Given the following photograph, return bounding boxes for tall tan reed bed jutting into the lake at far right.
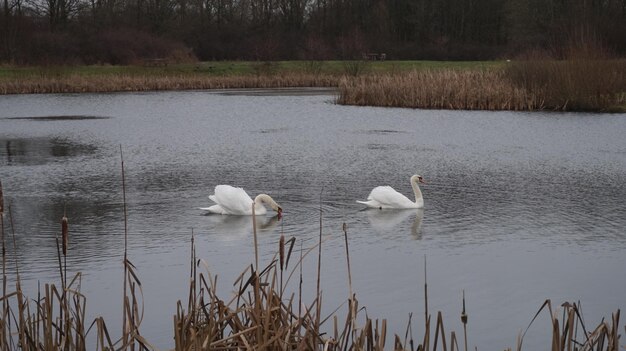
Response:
[338,59,626,112]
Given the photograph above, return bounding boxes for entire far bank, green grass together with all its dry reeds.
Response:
[0,58,626,112]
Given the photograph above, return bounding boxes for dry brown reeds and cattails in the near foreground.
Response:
[0,175,626,351]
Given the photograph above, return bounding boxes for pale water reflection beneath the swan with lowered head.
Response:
[200,214,280,240]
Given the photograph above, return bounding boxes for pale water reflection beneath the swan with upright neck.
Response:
[365,208,424,239]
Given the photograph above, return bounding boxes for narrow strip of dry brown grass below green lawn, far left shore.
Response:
[0,73,338,94]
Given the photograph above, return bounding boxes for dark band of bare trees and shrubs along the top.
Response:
[0,0,626,64]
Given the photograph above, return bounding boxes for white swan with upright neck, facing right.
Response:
[356,174,426,209]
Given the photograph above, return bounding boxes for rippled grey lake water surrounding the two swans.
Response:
[0,90,626,350]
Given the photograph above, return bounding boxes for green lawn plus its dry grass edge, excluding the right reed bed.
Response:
[0,61,500,94]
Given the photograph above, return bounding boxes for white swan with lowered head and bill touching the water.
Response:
[200,185,283,216]
